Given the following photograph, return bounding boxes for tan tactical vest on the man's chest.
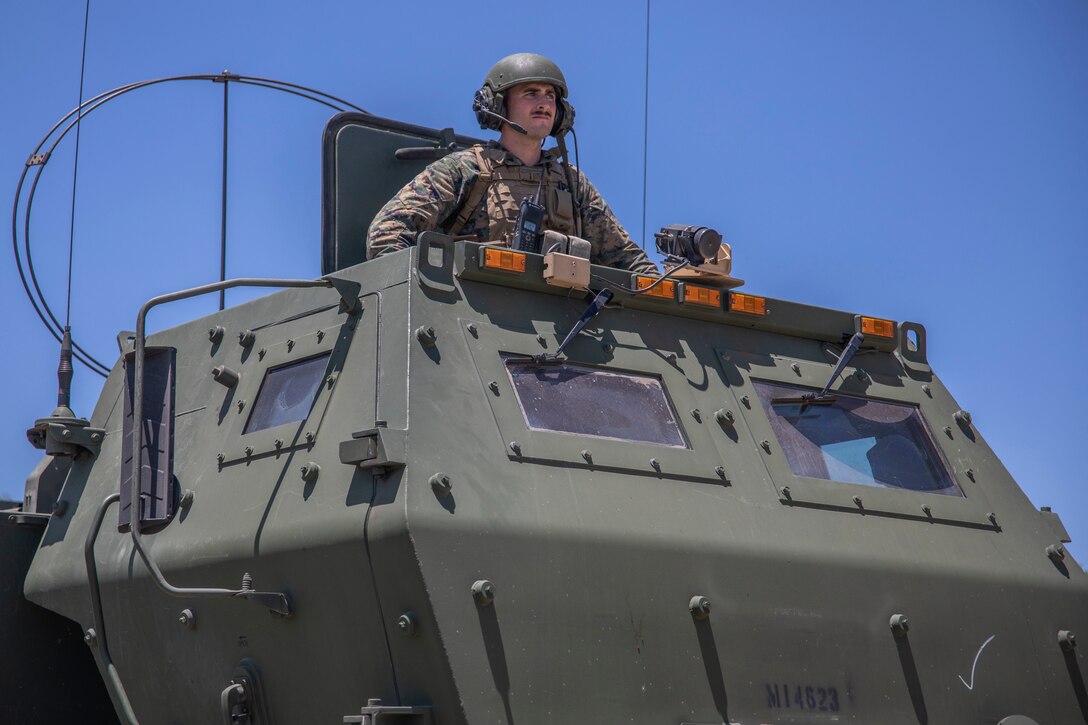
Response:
[449,146,578,245]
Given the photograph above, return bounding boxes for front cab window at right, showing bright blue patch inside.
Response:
[753,381,963,496]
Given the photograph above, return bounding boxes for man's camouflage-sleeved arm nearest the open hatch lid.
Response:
[367,153,478,259]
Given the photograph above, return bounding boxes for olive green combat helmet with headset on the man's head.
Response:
[472,53,574,136]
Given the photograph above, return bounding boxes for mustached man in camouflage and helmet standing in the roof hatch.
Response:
[367,53,657,274]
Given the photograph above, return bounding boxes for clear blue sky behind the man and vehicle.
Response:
[0,0,1088,561]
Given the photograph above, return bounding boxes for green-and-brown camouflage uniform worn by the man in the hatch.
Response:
[367,142,658,274]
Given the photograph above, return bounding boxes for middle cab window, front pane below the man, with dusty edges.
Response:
[507,361,687,447]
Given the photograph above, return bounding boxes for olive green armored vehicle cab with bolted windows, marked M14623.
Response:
[5,115,1088,725]
